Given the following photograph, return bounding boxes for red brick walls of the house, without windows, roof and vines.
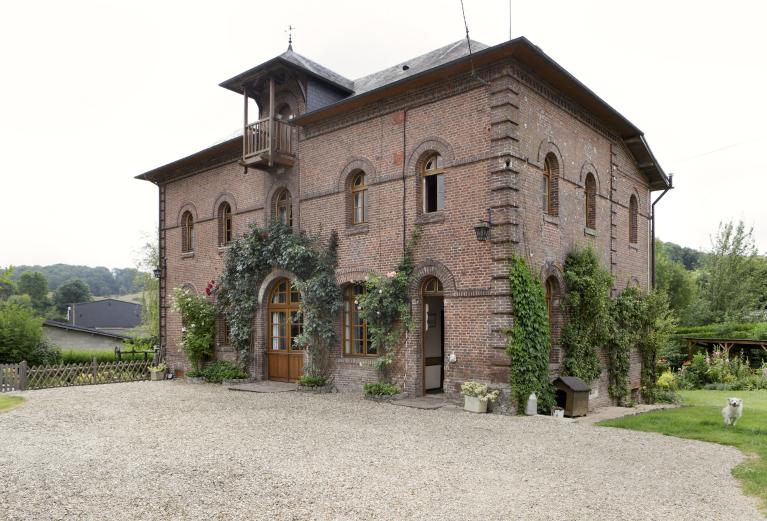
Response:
[160,58,649,402]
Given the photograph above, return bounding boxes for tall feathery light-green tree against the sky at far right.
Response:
[701,221,757,322]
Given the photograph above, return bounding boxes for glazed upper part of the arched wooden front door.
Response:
[269,279,303,352]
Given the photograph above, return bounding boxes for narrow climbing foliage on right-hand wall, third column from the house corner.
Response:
[607,286,645,405]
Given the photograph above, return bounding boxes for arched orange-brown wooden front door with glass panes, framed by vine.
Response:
[267,279,304,382]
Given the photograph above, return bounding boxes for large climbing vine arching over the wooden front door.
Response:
[216,221,341,375]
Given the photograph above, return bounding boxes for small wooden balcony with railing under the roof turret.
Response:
[242,118,295,168]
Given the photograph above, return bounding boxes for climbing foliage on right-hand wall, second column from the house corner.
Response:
[561,247,612,383]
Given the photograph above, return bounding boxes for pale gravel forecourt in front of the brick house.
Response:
[0,382,764,521]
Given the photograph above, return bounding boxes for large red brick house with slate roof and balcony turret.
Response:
[138,38,669,402]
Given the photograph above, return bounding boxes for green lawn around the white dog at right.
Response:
[599,391,767,512]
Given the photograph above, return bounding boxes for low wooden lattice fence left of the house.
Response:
[0,359,151,392]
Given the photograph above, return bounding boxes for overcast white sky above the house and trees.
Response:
[0,0,767,268]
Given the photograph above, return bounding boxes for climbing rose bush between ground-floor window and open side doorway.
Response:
[358,228,419,380]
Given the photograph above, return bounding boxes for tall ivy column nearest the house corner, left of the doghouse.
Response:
[506,256,554,414]
